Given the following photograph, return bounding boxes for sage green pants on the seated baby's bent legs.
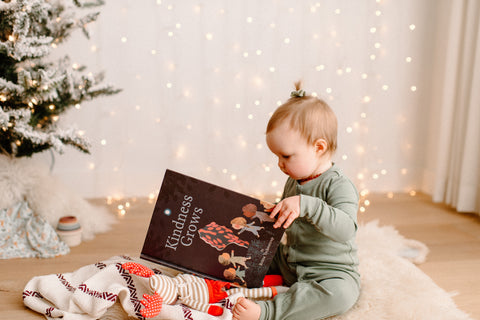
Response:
[257,251,360,320]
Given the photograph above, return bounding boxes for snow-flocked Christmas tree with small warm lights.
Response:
[0,0,119,157]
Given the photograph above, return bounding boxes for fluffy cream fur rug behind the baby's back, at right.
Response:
[94,221,473,320]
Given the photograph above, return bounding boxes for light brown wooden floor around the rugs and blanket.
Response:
[0,194,480,319]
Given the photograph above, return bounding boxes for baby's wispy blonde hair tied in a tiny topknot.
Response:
[266,81,338,154]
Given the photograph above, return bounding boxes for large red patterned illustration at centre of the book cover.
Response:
[198,222,249,251]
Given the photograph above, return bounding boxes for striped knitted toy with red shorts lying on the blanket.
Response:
[122,262,282,318]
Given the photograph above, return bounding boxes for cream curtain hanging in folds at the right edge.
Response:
[425,0,480,213]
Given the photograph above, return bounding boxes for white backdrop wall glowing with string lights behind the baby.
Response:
[36,0,437,205]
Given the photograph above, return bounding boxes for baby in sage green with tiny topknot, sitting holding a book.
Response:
[233,83,360,320]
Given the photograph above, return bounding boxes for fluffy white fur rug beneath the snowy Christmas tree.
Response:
[0,154,116,240]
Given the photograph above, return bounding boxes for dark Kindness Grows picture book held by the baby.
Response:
[140,169,284,288]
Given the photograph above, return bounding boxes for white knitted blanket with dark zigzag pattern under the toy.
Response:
[23,256,242,320]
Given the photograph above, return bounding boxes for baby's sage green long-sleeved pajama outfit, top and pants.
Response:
[258,164,360,320]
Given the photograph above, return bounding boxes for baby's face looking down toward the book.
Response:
[267,121,321,180]
